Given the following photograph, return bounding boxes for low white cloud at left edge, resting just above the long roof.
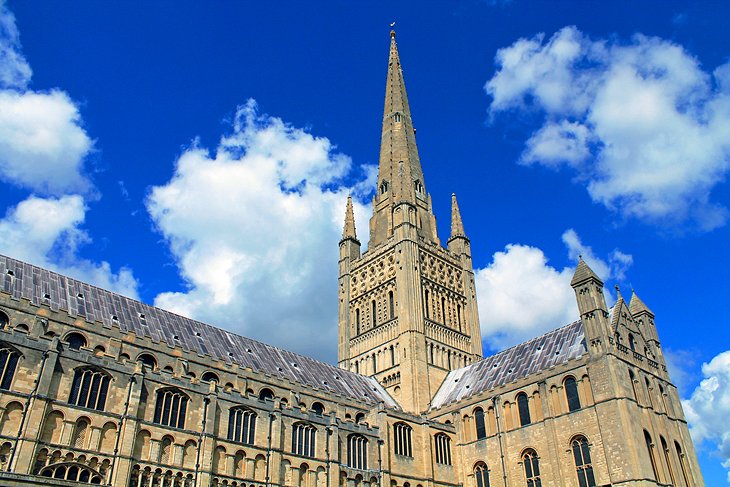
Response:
[0,195,137,298]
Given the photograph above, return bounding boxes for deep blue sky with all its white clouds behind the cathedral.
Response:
[0,0,730,485]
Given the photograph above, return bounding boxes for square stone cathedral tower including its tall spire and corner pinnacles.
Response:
[338,32,482,413]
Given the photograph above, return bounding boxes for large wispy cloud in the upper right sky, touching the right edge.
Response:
[485,27,730,230]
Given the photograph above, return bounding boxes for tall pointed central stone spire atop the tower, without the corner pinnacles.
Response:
[378,31,426,202]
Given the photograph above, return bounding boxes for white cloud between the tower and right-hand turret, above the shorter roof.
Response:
[475,229,632,350]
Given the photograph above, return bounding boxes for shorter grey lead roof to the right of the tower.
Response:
[431,321,588,409]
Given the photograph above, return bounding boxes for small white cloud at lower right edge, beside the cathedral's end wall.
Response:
[682,350,730,482]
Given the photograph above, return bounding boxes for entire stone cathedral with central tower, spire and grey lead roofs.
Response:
[0,32,704,487]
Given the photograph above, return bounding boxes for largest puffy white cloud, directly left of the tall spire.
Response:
[147,101,373,360]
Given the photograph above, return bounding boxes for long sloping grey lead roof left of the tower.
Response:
[0,255,398,407]
